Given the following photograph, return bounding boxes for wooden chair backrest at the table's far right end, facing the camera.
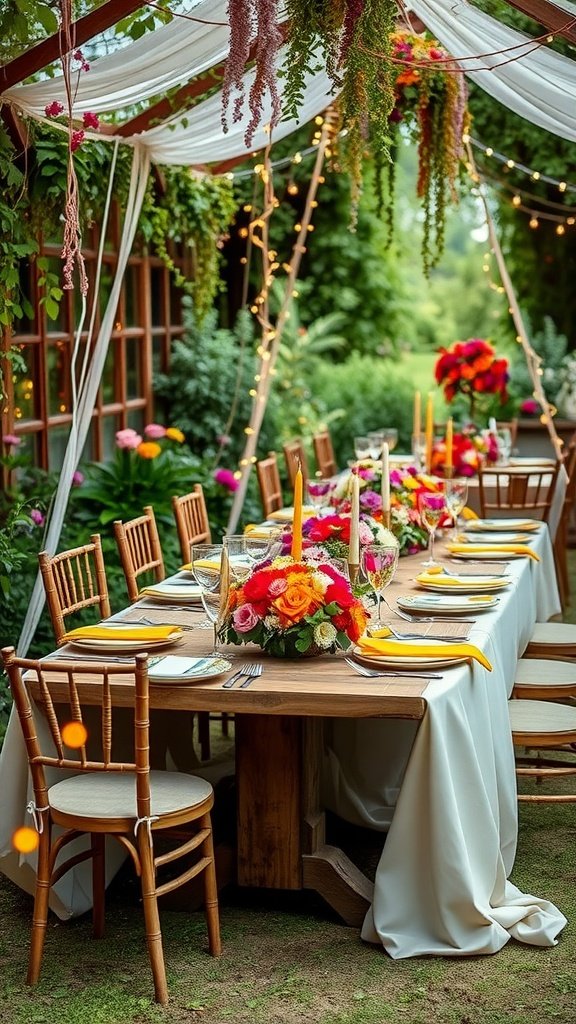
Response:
[478,462,562,522]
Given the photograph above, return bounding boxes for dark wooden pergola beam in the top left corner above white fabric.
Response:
[0,0,142,93]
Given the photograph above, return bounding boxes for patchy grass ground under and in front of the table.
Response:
[0,553,576,1024]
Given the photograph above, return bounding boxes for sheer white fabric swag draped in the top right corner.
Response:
[410,0,576,141]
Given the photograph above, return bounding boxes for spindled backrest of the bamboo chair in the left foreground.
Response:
[2,647,150,818]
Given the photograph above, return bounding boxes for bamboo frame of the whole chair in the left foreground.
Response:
[2,647,221,1004]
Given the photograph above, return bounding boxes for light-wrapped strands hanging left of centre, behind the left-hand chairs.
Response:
[227,109,336,534]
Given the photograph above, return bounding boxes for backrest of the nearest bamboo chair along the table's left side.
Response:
[38,534,111,643]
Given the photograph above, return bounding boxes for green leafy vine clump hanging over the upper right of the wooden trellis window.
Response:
[139,167,237,319]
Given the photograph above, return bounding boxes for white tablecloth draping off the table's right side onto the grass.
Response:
[325,527,566,958]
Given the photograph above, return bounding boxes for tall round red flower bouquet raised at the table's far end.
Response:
[435,338,509,419]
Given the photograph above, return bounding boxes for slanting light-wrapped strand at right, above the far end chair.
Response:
[464,135,564,460]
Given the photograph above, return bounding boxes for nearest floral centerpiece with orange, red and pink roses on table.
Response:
[218,555,369,657]
